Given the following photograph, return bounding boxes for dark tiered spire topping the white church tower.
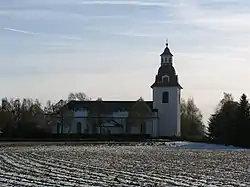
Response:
[151,42,181,88]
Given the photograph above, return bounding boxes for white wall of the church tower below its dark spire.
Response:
[153,87,180,136]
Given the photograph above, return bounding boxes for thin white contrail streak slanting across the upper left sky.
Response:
[3,27,82,40]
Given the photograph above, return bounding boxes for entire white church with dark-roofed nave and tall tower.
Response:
[52,43,182,137]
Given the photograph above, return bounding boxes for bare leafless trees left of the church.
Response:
[0,92,91,137]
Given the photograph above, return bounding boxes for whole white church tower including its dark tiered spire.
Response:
[151,42,182,137]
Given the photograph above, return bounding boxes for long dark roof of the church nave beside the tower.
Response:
[67,101,153,113]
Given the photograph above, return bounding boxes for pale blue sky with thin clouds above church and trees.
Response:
[0,0,250,124]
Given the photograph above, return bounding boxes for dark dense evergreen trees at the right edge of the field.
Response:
[207,93,250,147]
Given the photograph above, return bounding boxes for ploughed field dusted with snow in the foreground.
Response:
[0,142,250,187]
